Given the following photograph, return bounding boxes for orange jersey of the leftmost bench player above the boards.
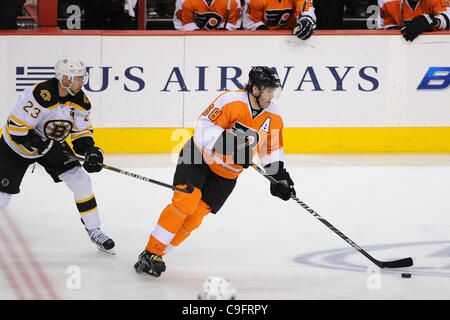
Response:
[173,0,242,31]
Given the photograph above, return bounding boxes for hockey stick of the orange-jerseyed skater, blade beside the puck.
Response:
[252,164,413,268]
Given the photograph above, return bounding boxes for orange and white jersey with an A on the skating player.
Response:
[194,90,284,179]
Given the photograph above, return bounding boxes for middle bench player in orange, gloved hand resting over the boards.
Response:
[243,0,316,40]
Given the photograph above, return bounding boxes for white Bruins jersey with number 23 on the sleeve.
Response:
[3,78,93,159]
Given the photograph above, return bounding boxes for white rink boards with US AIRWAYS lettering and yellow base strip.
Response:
[0,31,450,153]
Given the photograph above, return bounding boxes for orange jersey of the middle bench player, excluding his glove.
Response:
[243,0,316,30]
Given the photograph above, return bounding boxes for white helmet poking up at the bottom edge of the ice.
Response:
[198,276,236,300]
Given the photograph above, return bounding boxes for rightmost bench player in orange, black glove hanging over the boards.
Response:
[378,0,450,41]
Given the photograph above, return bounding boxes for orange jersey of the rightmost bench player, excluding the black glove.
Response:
[378,0,450,30]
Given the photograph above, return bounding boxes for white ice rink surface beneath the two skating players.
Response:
[0,154,450,300]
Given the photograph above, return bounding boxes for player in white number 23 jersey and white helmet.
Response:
[0,57,115,254]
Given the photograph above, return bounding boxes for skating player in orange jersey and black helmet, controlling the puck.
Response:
[134,67,295,277]
